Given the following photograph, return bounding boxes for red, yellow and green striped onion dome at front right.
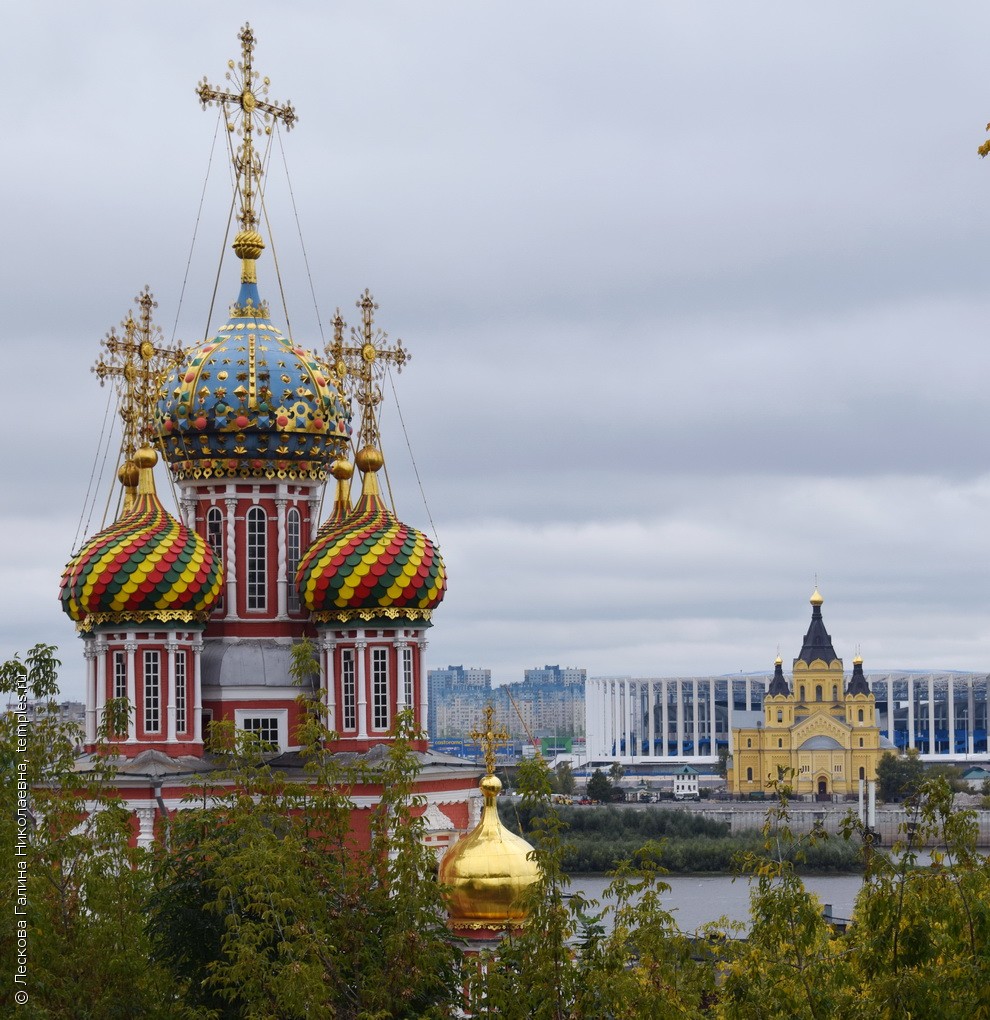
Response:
[296,450,447,623]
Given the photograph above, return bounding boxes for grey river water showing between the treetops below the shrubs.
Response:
[568,875,863,931]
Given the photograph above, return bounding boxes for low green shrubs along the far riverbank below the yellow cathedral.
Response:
[500,803,863,874]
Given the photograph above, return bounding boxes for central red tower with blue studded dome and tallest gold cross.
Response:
[159,26,351,750]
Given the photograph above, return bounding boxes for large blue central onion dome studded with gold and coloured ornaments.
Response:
[158,231,351,481]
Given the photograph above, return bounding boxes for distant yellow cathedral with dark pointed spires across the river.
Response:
[727,589,886,800]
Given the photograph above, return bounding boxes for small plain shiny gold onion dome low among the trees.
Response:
[439,775,539,928]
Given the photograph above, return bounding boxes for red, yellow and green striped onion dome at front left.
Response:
[59,449,223,631]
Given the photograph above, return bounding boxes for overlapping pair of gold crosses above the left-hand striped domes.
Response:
[93,287,185,462]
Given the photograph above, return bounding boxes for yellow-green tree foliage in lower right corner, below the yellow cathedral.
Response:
[715,777,990,1020]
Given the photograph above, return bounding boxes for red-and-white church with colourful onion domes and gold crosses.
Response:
[60,26,481,850]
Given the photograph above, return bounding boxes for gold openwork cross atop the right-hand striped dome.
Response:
[325,290,412,449]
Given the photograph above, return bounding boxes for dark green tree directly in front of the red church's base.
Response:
[150,693,460,1020]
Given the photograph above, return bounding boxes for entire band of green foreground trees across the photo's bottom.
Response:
[7,646,990,1020]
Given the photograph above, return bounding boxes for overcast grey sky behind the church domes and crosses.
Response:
[7,0,990,697]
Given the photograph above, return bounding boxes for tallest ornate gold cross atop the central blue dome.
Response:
[196,23,299,231]
